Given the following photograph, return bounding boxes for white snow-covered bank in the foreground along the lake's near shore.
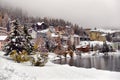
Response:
[0,52,120,80]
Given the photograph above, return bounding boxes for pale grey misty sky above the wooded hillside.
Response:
[0,0,120,29]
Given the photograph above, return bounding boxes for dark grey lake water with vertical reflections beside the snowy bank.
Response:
[53,55,120,72]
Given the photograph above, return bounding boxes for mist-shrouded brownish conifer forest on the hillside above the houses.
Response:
[0,5,83,34]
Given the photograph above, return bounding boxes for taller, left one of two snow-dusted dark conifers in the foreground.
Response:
[5,20,24,55]
